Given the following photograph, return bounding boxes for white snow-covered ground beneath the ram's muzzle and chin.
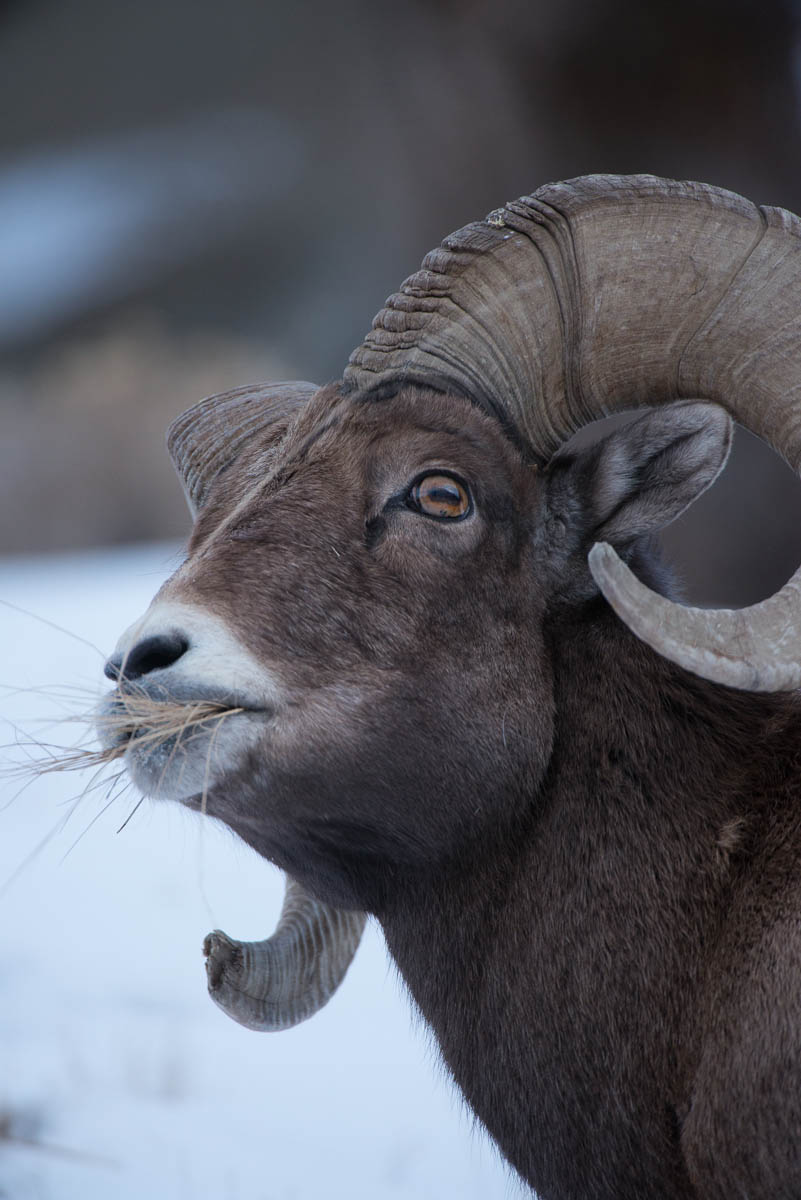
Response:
[0,546,529,1200]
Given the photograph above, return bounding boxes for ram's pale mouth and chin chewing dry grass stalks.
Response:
[96,685,271,799]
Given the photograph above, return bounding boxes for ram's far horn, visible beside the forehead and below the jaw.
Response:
[167,383,366,1030]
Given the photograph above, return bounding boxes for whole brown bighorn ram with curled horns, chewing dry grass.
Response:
[101,175,801,1200]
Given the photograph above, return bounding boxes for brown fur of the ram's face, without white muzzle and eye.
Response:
[162,388,553,910]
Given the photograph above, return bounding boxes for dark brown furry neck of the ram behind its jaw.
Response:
[383,616,799,1200]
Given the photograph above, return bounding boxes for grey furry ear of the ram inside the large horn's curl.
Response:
[576,402,733,547]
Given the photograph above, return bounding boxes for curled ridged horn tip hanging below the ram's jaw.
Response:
[203,878,366,1031]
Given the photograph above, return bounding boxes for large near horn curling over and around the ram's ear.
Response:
[345,175,801,691]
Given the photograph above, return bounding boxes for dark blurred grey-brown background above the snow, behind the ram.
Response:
[0,0,801,604]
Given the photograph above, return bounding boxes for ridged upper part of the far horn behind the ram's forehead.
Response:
[167,382,318,516]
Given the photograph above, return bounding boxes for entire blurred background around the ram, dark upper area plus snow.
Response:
[0,0,801,1200]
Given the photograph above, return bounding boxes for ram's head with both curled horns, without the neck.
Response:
[102,176,801,1028]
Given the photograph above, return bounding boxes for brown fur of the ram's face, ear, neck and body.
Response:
[128,388,801,1200]
